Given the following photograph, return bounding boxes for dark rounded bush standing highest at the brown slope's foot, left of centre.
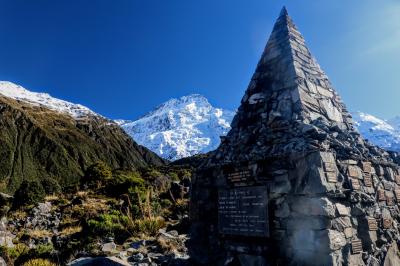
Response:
[82,161,112,188]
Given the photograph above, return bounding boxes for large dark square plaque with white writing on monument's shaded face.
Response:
[218,186,269,237]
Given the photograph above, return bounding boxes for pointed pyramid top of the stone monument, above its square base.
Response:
[208,7,390,162]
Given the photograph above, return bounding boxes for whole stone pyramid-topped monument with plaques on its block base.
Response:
[190,8,400,265]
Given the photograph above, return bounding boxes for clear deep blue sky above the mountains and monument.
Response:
[0,0,400,119]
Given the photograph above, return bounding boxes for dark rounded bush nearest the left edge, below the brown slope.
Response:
[13,180,45,208]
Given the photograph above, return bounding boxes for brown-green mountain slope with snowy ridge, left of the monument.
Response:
[0,82,164,192]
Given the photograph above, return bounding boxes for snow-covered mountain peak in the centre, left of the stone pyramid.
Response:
[116,94,235,160]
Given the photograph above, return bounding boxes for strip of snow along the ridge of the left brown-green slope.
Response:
[0,81,98,118]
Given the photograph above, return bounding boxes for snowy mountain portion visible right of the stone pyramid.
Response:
[352,112,400,151]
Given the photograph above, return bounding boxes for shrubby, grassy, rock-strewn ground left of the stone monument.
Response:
[0,162,191,265]
